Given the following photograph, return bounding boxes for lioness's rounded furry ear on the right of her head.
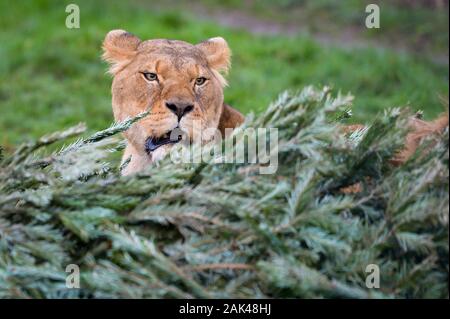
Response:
[197,37,231,73]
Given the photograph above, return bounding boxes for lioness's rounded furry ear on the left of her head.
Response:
[102,30,141,74]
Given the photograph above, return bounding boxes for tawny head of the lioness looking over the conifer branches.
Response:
[103,30,243,172]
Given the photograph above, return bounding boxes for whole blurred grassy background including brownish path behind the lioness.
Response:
[0,0,449,151]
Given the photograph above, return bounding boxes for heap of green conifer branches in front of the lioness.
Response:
[0,87,449,298]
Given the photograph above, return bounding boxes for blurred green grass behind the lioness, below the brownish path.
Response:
[0,1,449,148]
